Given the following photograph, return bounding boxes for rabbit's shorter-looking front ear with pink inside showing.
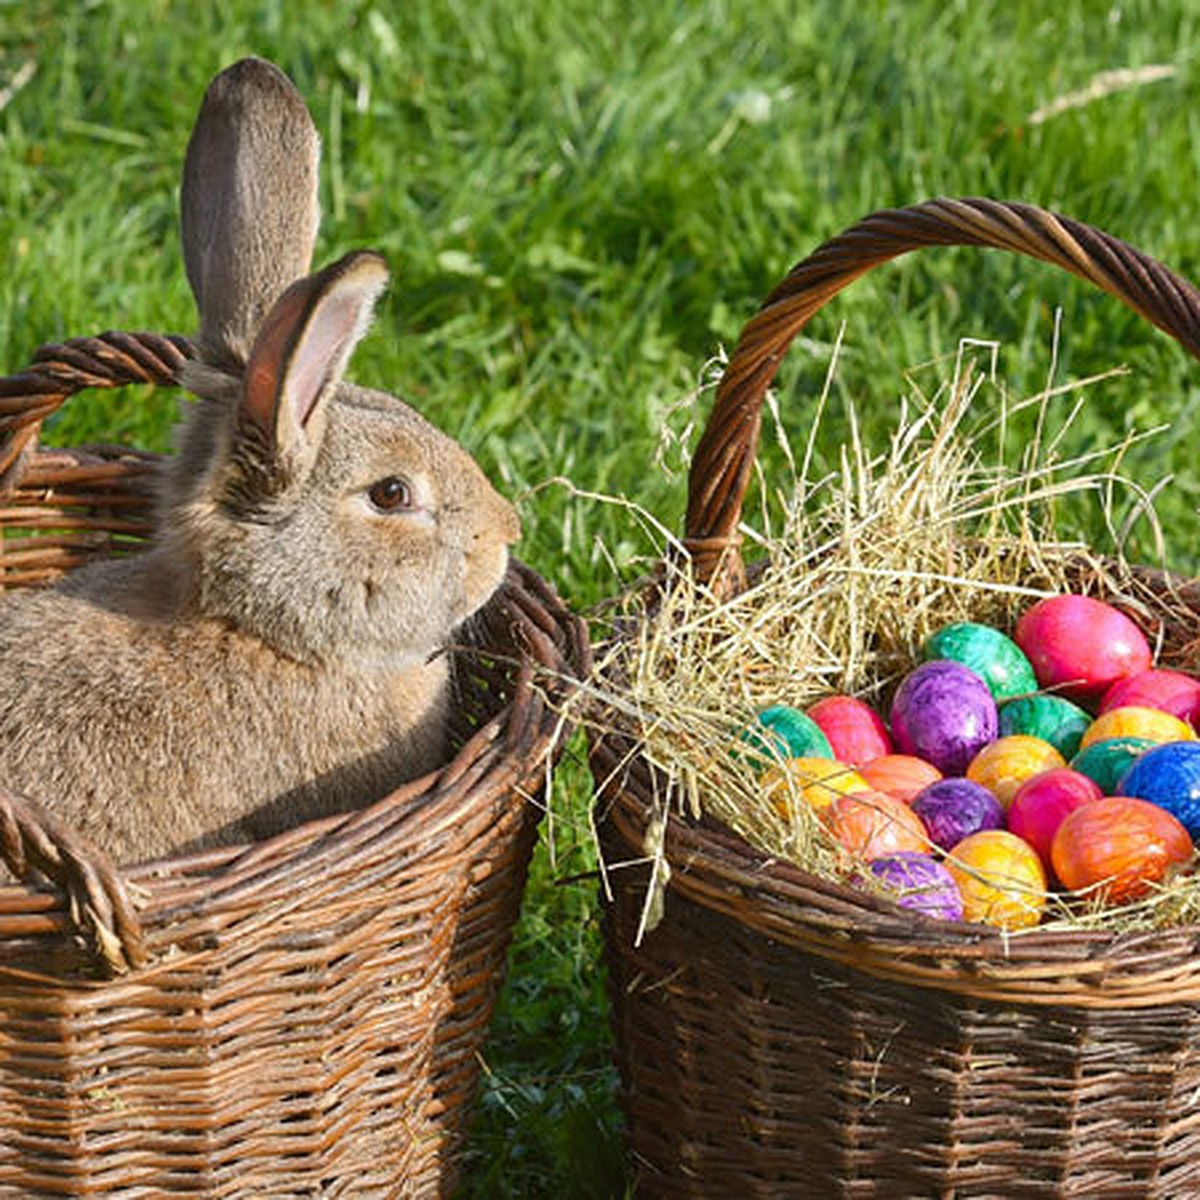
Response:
[241,250,388,464]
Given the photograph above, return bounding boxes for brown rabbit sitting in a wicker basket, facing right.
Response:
[0,59,520,863]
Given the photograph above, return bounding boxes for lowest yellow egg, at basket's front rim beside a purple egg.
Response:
[946,829,1046,929]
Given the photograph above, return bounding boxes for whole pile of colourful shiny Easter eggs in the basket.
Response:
[744,595,1200,930]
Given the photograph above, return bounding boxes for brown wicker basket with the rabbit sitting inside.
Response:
[0,334,588,1196]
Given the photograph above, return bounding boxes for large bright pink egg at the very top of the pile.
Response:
[1015,595,1151,702]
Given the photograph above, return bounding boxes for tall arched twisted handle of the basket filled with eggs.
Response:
[683,199,1200,592]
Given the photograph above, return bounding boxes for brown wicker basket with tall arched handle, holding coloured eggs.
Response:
[592,192,1200,1200]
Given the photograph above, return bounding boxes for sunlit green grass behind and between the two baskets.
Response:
[0,0,1200,1196]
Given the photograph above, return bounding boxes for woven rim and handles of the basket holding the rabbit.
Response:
[0,331,592,988]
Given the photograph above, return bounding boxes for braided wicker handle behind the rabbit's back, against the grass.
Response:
[0,330,196,496]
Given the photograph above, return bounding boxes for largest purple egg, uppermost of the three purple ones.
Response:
[892,659,1000,775]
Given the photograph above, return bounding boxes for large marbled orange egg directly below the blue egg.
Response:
[1050,796,1192,904]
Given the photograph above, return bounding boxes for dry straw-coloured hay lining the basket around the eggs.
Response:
[573,336,1200,929]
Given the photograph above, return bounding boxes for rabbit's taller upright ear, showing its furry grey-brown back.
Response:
[180,58,320,366]
